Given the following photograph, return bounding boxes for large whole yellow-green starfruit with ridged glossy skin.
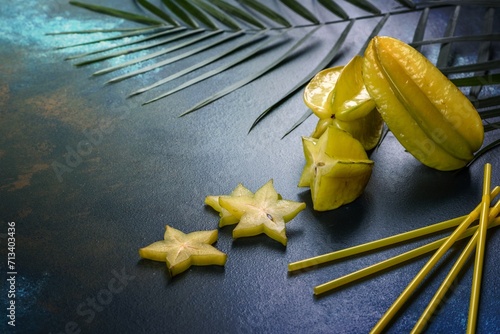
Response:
[363,36,484,171]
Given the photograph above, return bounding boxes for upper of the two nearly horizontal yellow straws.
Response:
[288,186,500,271]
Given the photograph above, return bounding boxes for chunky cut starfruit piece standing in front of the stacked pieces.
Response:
[299,126,373,211]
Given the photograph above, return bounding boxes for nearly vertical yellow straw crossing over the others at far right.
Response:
[467,164,491,334]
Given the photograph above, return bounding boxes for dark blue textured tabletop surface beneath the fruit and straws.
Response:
[0,0,500,333]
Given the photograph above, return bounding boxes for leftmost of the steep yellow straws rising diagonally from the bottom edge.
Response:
[371,167,494,333]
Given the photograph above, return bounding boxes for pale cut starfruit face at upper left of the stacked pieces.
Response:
[302,66,344,119]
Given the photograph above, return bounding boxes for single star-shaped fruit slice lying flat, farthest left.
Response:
[139,225,227,276]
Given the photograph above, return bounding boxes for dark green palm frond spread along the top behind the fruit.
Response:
[53,0,500,162]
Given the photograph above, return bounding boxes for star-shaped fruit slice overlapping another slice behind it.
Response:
[219,179,306,246]
